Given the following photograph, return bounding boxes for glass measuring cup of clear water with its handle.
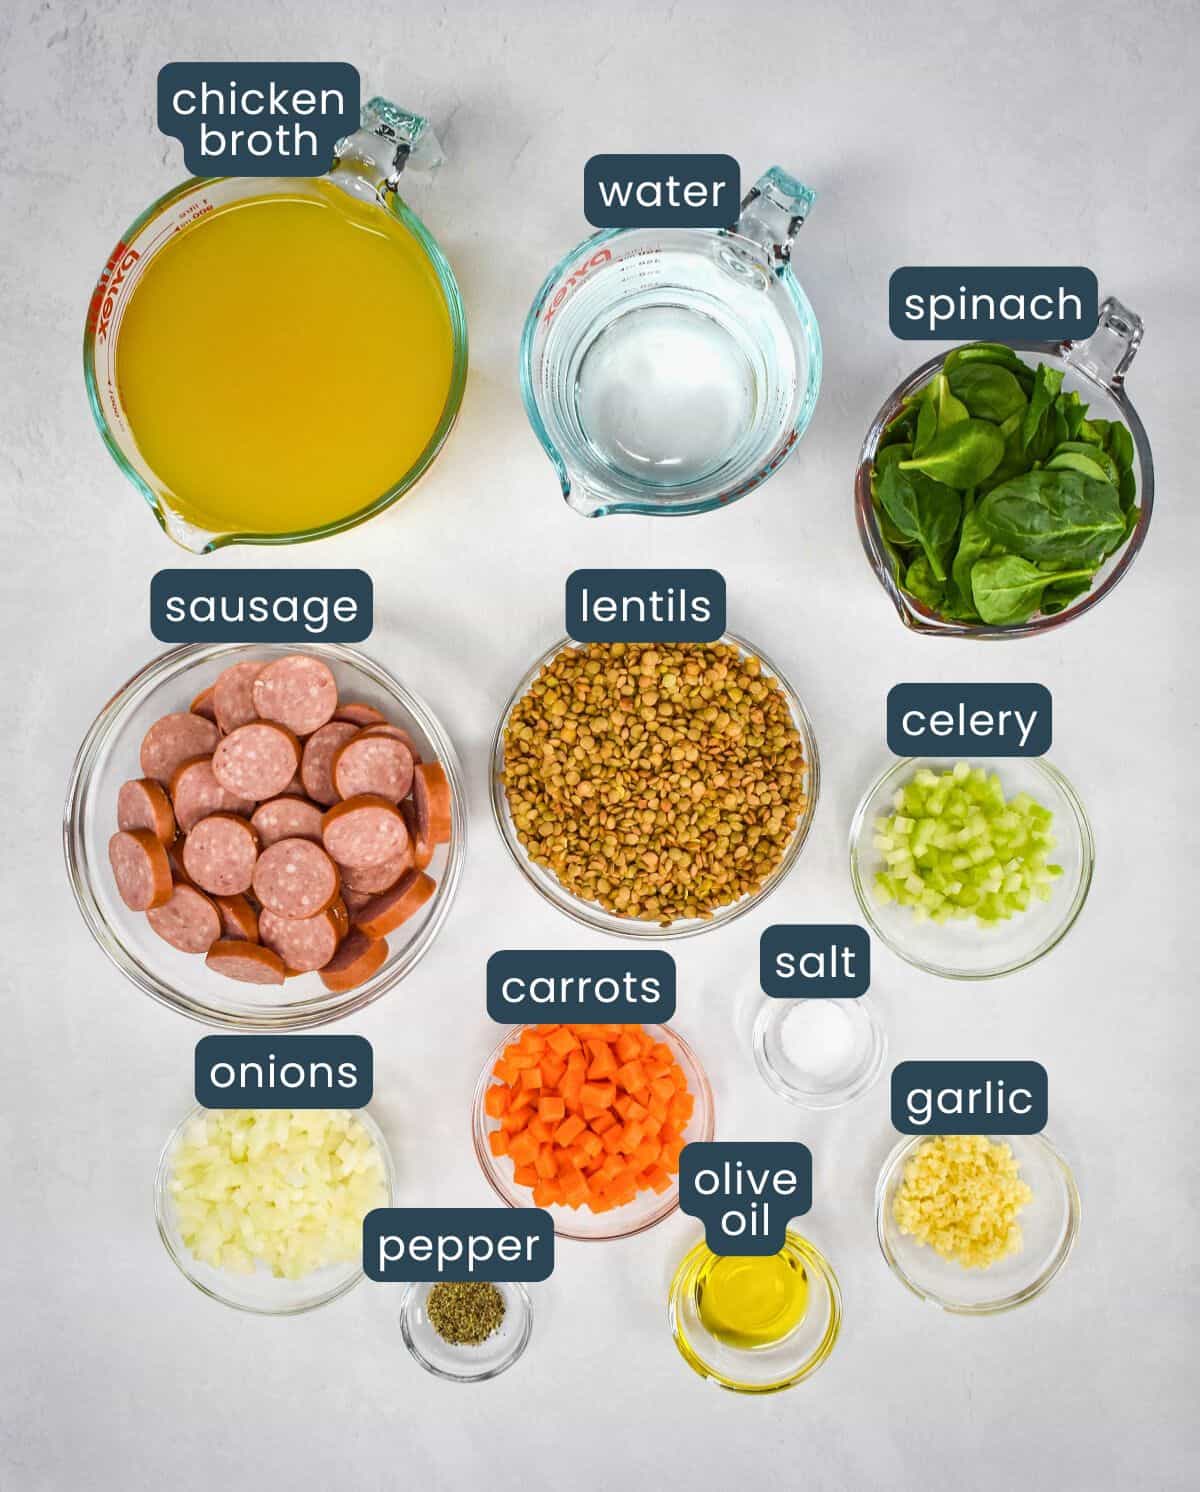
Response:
[521,167,821,518]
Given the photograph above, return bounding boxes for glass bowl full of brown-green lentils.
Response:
[491,633,821,940]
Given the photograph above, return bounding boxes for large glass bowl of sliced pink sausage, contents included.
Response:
[63,643,466,1031]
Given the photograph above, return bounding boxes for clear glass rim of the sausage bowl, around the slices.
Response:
[63,643,467,1031]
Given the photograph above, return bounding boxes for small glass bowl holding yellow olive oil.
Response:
[667,1231,842,1394]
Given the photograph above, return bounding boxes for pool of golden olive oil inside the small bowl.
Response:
[696,1250,809,1350]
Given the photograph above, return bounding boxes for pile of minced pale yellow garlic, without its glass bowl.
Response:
[891,1134,1033,1270]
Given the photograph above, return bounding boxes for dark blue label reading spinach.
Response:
[888,264,1100,342]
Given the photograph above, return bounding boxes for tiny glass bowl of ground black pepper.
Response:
[400,1280,533,1383]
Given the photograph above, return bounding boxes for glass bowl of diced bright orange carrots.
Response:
[472,1024,713,1238]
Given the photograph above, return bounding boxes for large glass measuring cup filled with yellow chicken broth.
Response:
[84,98,467,554]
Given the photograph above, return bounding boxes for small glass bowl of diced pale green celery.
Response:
[851,756,1096,979]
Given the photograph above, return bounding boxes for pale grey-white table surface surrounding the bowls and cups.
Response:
[0,0,1200,1492]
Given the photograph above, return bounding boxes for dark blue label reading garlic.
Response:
[891,1062,1049,1134]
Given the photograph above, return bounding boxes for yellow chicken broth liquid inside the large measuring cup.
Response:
[116,181,454,534]
